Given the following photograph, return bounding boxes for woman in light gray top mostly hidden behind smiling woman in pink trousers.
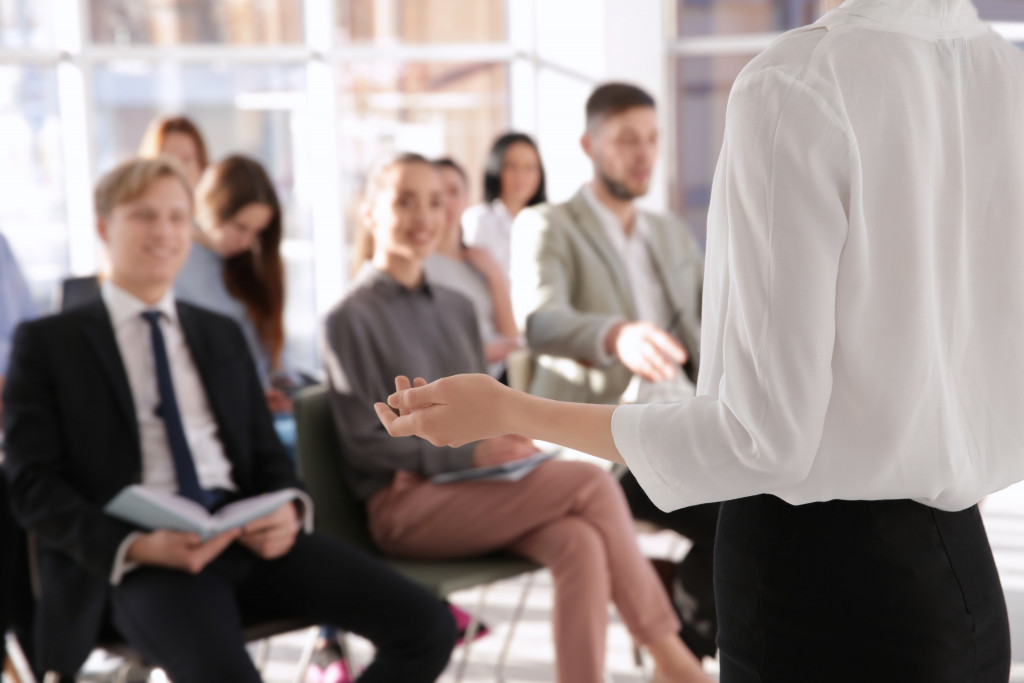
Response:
[424,159,519,378]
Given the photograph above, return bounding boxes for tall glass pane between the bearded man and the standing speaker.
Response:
[672,54,754,244]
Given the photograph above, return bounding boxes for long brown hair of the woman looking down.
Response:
[196,155,285,367]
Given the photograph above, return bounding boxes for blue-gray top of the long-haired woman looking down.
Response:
[174,241,270,387]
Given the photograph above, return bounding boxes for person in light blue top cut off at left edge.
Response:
[0,234,37,667]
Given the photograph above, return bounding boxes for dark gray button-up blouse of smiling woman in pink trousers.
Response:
[325,263,486,500]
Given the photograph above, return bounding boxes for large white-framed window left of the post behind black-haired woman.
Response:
[0,0,512,370]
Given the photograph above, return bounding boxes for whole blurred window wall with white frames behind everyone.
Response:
[0,0,1024,368]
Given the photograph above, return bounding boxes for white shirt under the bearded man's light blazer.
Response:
[583,184,694,403]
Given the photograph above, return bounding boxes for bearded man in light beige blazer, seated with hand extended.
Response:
[511,83,718,657]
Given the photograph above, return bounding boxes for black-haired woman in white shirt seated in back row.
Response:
[462,133,548,278]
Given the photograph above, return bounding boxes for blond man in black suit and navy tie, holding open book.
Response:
[4,160,455,683]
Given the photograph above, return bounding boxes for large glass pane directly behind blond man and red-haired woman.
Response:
[93,63,319,372]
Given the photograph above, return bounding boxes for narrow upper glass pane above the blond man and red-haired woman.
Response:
[89,0,302,45]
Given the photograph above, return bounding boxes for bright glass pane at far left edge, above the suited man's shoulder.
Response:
[0,66,70,311]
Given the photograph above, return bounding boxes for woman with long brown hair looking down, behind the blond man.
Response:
[174,155,294,436]
